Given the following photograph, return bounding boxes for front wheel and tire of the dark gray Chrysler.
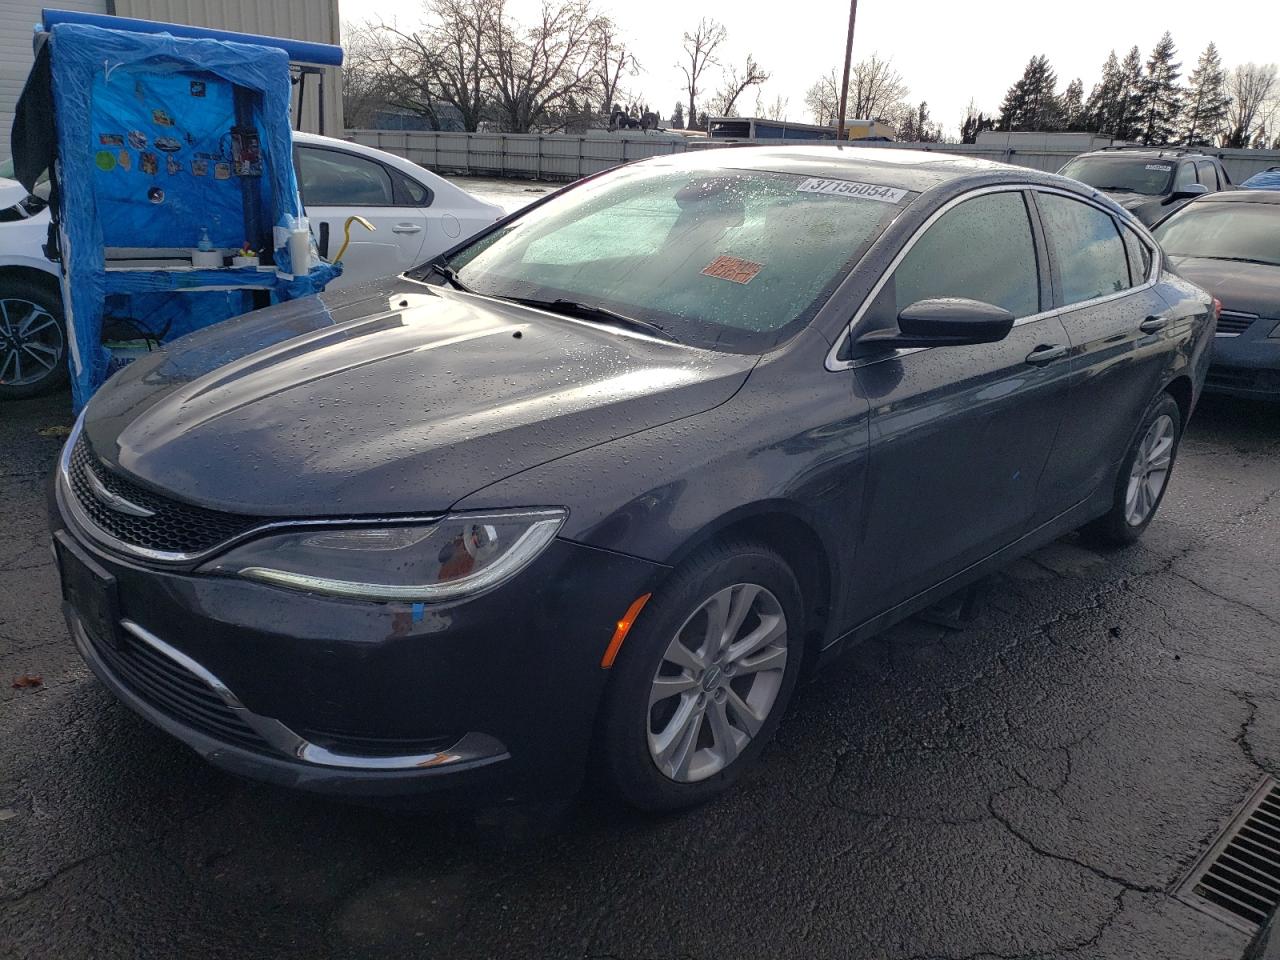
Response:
[596,541,804,812]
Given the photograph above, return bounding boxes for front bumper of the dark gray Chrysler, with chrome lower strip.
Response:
[51,485,663,804]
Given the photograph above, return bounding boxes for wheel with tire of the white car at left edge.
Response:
[0,278,69,401]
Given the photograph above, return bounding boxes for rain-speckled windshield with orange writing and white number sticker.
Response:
[449,164,914,352]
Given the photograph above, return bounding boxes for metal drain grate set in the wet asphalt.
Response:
[1178,777,1280,933]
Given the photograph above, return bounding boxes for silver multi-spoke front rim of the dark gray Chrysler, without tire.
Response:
[649,584,787,783]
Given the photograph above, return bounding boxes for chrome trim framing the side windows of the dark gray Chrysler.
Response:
[823,183,1161,372]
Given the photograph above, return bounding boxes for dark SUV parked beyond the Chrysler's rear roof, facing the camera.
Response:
[1059,147,1233,227]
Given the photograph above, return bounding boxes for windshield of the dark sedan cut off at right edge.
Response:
[1155,202,1280,266]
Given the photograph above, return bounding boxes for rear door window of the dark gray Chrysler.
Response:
[1036,193,1130,305]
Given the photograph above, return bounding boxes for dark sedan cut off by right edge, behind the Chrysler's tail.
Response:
[1155,189,1280,401]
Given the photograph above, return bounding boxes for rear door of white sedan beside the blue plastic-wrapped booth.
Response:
[294,145,430,289]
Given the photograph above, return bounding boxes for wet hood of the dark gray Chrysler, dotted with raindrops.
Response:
[83,278,756,516]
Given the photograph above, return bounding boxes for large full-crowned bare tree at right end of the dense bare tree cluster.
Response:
[484,0,598,133]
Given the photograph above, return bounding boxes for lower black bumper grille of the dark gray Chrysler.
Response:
[86,631,271,753]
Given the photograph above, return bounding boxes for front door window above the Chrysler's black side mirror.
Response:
[877,192,1039,320]
